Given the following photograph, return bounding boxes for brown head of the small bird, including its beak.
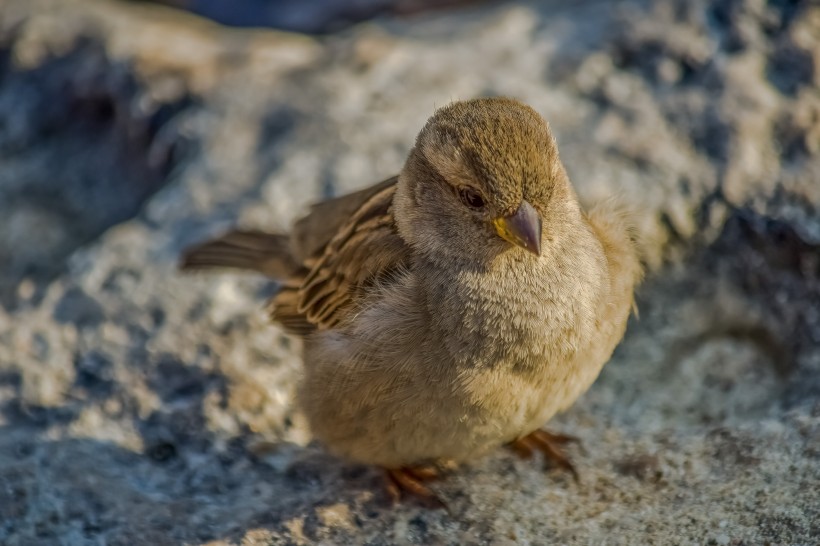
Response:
[395,98,578,259]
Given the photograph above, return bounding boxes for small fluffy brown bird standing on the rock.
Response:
[181,98,642,506]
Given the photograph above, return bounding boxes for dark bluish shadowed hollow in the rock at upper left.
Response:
[0,31,193,307]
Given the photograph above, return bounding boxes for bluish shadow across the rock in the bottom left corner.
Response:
[0,429,388,546]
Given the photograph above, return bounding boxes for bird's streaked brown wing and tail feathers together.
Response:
[180,177,409,335]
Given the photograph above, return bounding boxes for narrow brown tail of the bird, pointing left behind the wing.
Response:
[179,230,300,279]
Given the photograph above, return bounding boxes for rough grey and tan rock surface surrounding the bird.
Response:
[0,0,820,546]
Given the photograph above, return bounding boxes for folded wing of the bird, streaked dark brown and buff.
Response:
[271,178,410,333]
